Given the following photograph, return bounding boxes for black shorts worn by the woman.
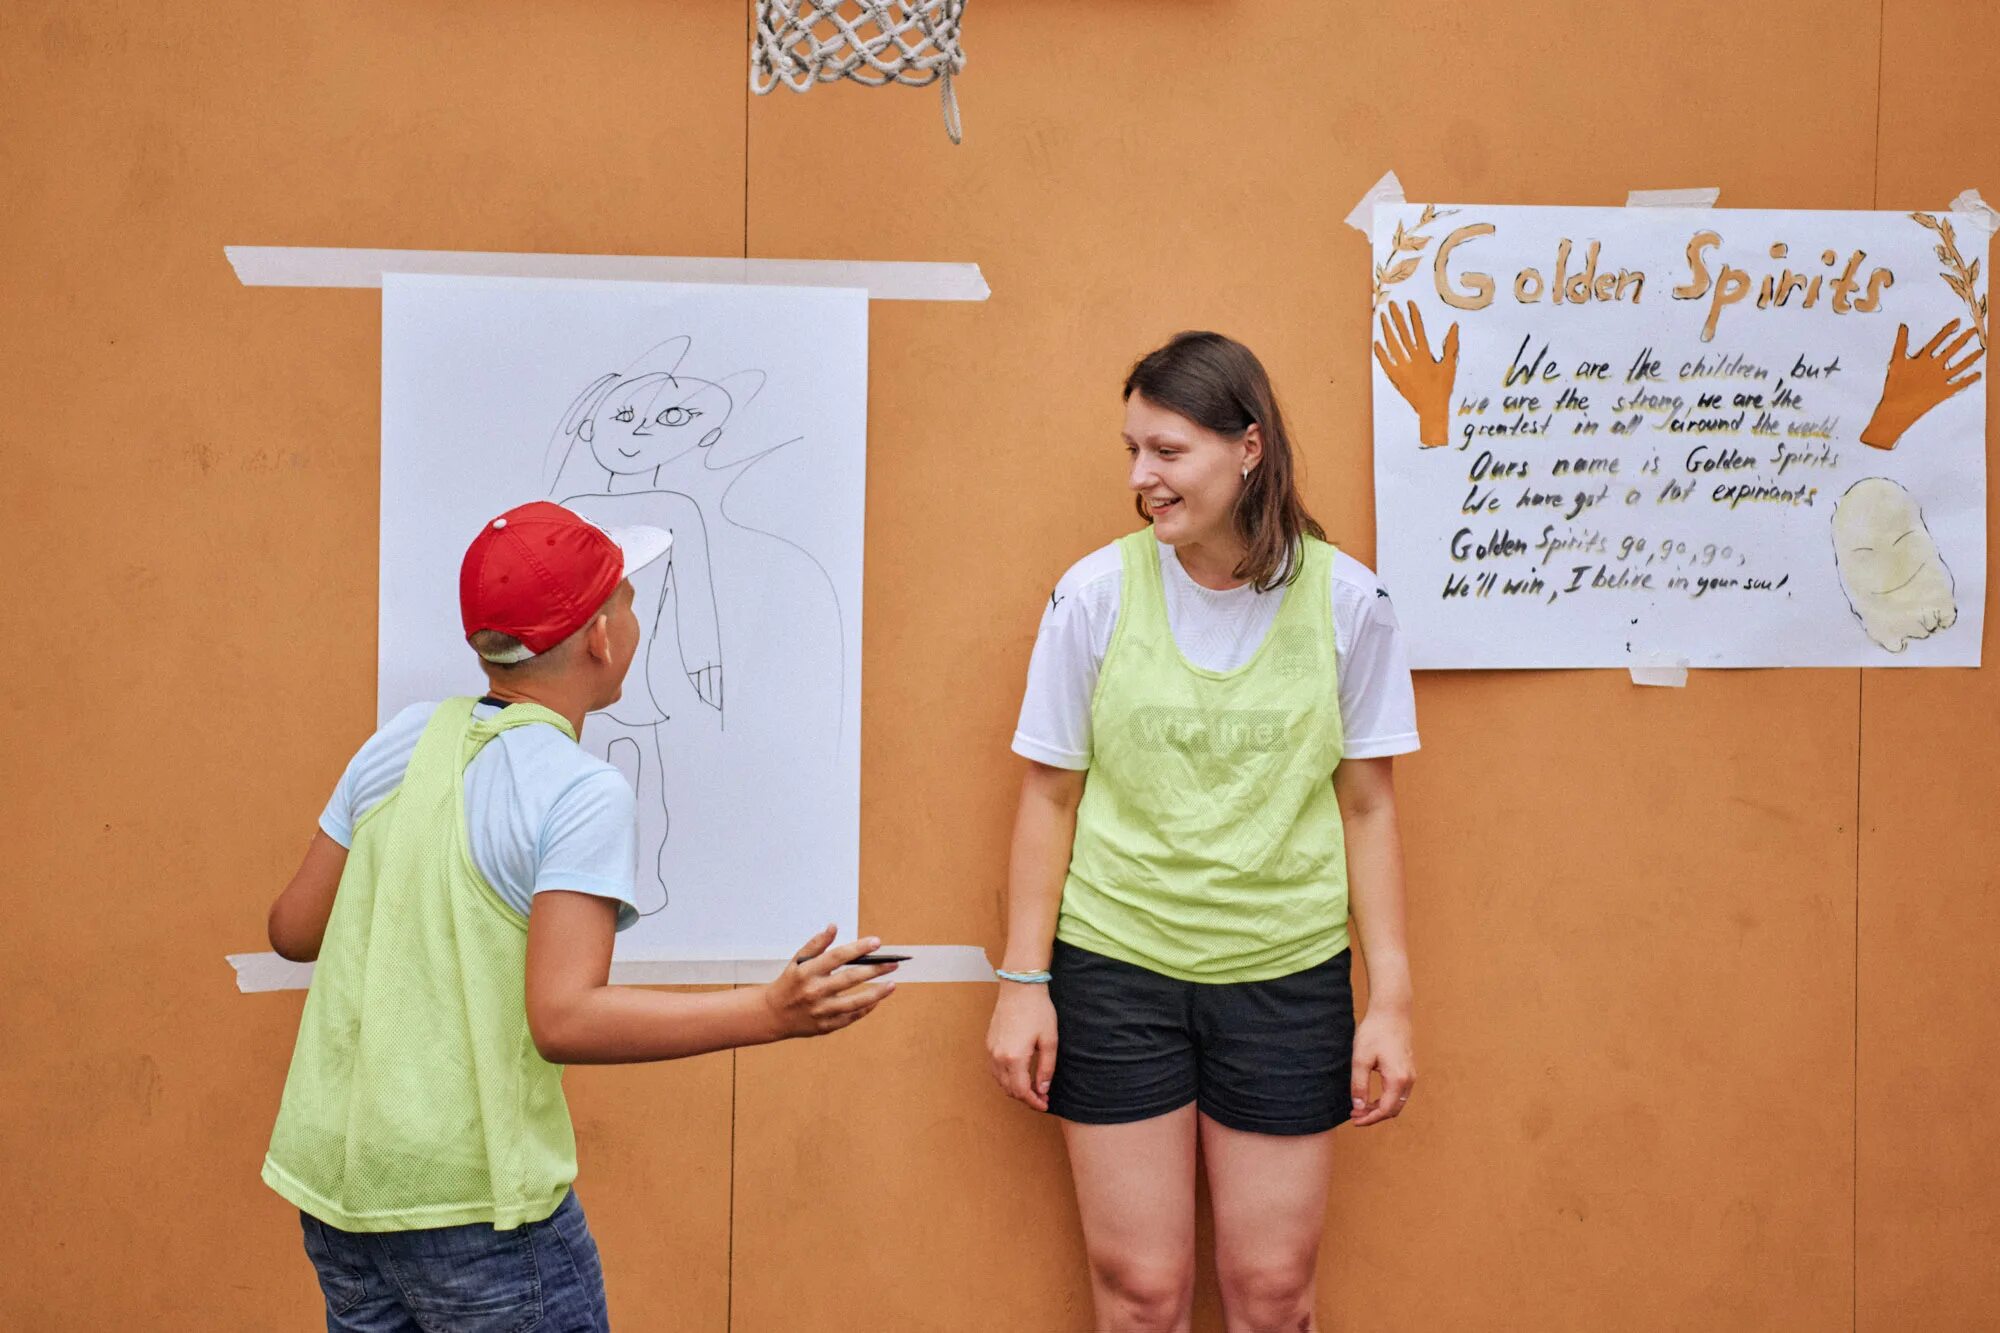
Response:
[1048,939,1354,1135]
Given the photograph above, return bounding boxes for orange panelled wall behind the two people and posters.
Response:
[0,0,2000,1333]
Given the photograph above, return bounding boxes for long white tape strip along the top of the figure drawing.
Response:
[222,246,992,300]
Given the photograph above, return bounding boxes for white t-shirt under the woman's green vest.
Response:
[1014,542,1416,769]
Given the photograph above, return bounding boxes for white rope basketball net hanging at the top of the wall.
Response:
[750,0,966,144]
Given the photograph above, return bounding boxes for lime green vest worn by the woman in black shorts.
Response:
[1056,528,1348,983]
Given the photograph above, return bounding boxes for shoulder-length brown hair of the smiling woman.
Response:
[1124,332,1326,592]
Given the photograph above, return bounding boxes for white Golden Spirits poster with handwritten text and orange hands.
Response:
[1372,204,1988,669]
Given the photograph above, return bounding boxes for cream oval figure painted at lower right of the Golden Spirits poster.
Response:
[1834,476,1958,652]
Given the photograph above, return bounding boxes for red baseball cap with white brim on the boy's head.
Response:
[458,500,674,662]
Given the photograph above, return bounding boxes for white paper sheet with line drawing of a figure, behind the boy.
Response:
[378,276,868,959]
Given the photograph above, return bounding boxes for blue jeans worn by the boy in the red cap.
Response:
[298,1191,612,1333]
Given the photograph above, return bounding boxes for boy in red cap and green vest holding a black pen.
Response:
[264,502,896,1333]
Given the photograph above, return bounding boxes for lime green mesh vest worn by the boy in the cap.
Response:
[264,699,576,1231]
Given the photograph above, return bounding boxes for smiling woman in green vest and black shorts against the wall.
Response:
[988,332,1416,1333]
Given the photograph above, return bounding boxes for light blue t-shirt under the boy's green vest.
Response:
[320,703,638,931]
